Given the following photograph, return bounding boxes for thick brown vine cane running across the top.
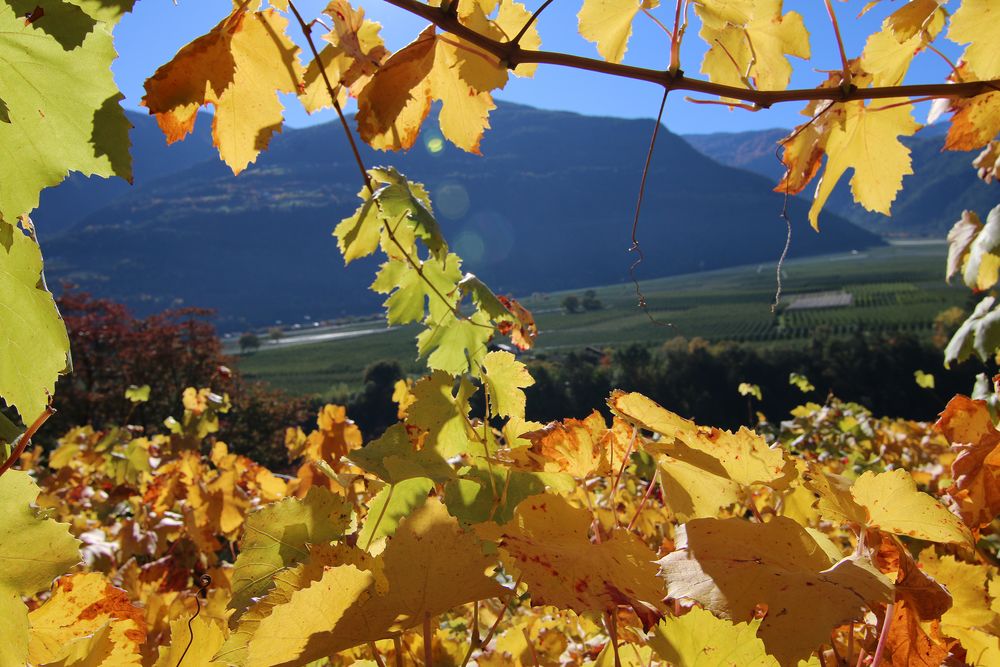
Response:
[386,0,1000,108]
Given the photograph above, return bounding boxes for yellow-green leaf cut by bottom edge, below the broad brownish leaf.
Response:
[649,607,778,667]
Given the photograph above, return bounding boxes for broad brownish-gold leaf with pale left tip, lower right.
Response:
[659,517,893,665]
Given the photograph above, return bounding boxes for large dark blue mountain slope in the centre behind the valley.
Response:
[42,104,882,329]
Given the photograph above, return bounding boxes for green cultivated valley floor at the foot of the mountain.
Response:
[232,242,969,395]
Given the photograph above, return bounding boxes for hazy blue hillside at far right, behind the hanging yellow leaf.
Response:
[684,124,1000,238]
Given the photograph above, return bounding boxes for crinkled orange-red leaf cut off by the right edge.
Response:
[934,396,1000,531]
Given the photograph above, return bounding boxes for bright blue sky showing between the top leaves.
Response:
[114,0,961,134]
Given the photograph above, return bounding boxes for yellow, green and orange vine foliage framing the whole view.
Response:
[0,0,1000,667]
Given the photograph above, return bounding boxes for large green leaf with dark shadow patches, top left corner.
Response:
[0,0,132,220]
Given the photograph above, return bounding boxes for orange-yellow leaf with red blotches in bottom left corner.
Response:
[28,572,146,667]
